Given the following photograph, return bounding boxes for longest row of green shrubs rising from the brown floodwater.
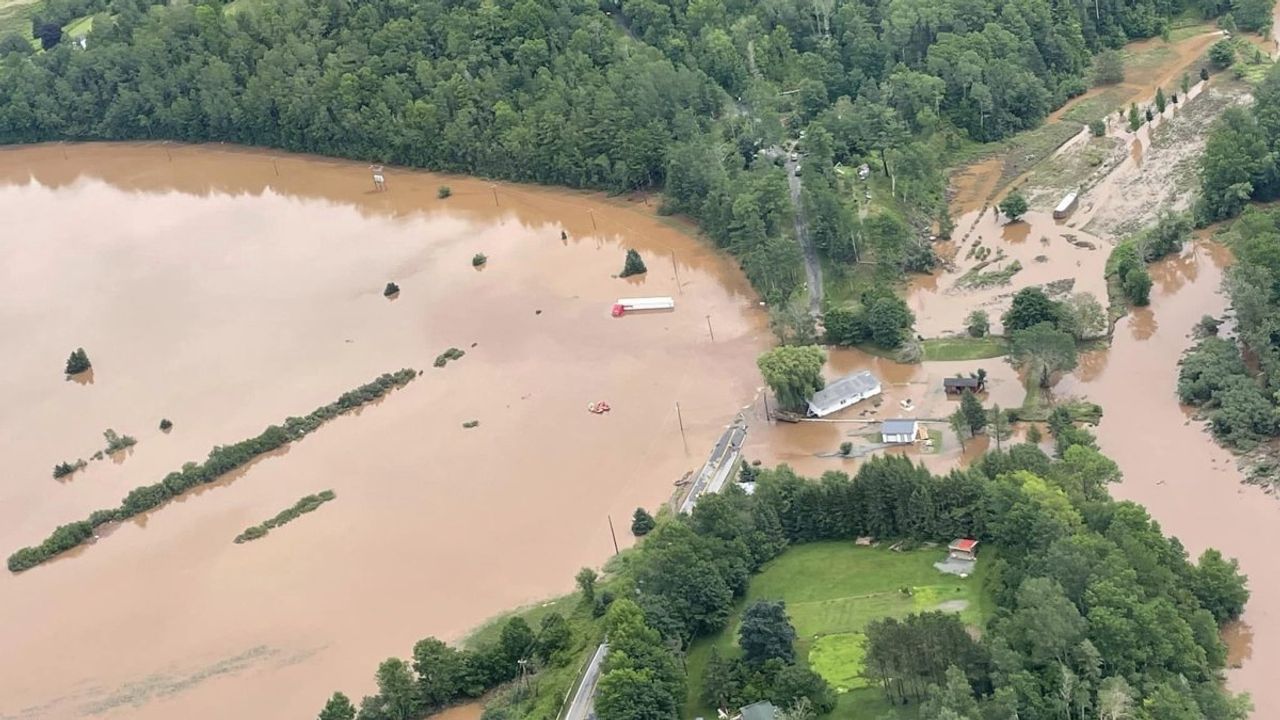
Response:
[9,368,419,573]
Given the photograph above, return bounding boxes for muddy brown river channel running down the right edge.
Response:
[1055,242,1280,719]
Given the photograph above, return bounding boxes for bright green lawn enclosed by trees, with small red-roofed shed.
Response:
[684,542,991,719]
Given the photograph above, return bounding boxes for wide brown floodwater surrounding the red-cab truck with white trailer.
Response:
[0,145,769,720]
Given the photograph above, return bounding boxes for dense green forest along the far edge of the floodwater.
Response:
[0,0,1198,302]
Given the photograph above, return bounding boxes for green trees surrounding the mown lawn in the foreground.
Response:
[332,423,1248,720]
